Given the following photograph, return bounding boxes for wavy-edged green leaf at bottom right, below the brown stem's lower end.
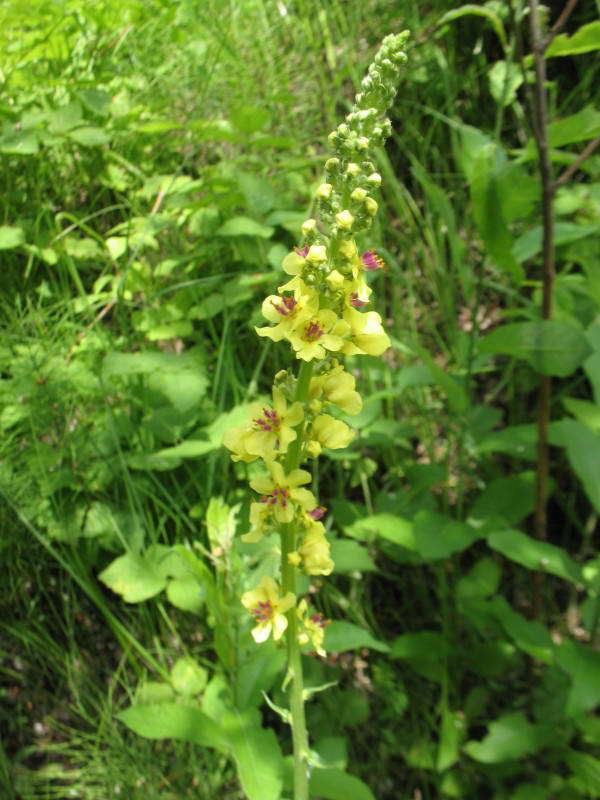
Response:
[463,711,552,764]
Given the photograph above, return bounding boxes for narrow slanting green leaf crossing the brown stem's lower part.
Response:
[487,532,583,583]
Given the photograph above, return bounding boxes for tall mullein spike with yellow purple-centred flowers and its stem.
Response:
[223,32,408,800]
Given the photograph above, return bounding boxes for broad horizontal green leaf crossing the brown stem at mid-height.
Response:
[479,320,591,378]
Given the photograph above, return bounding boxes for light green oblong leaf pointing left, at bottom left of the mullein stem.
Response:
[116,703,229,752]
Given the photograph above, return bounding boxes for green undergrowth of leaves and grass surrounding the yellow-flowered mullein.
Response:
[0,0,600,800]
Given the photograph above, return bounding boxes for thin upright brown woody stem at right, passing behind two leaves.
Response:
[529,0,552,617]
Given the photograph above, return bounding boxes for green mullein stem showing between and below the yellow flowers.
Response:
[281,361,313,800]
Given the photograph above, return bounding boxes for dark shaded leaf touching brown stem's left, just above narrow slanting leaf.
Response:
[469,472,535,525]
